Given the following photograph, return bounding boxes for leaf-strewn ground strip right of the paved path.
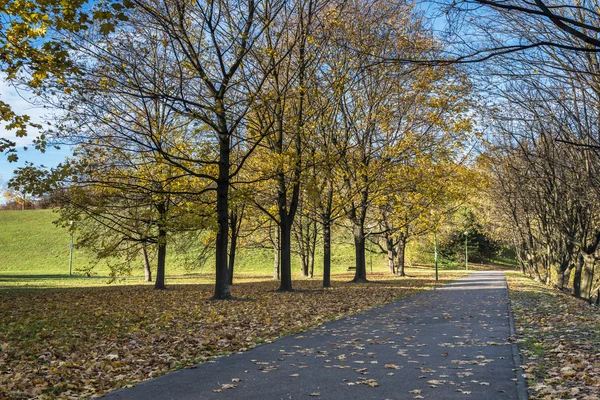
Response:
[507,272,600,400]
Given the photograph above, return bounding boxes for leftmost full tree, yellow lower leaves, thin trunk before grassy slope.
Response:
[14,11,220,289]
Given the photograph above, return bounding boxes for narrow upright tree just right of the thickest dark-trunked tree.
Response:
[245,0,326,291]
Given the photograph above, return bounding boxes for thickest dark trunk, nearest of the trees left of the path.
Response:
[213,131,231,300]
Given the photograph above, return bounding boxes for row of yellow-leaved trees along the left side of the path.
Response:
[8,0,475,299]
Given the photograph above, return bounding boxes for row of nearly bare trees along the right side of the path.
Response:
[486,2,600,299]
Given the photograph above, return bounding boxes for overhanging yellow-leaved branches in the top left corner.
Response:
[0,0,131,162]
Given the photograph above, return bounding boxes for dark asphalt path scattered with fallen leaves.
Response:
[107,272,524,400]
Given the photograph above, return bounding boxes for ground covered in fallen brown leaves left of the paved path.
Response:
[0,275,462,399]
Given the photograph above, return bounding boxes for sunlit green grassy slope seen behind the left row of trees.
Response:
[0,210,387,286]
